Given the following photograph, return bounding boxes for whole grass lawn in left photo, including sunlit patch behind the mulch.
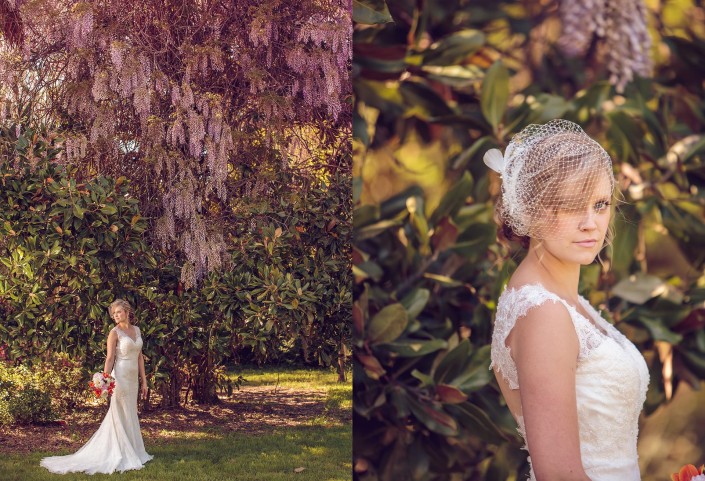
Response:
[0,368,352,481]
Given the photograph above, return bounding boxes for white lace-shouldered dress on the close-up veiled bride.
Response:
[490,284,649,481]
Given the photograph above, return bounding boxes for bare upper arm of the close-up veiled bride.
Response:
[510,302,590,481]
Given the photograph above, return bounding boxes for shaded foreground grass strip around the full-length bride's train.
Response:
[0,425,352,481]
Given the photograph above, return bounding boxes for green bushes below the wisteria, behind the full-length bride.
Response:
[0,126,351,410]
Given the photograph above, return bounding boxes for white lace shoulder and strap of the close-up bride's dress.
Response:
[490,284,608,389]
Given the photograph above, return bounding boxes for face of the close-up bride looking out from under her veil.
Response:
[542,172,612,265]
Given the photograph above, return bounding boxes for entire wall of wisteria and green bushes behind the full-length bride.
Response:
[0,0,352,418]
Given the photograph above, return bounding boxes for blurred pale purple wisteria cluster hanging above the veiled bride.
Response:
[559,0,652,92]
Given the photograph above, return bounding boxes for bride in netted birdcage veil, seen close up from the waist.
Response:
[485,120,649,481]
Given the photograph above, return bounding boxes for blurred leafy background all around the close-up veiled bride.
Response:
[353,0,705,481]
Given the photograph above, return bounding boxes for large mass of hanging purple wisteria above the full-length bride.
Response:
[0,0,352,285]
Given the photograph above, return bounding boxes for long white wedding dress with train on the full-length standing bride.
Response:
[40,326,153,474]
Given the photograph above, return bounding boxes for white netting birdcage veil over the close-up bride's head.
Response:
[484,119,615,239]
